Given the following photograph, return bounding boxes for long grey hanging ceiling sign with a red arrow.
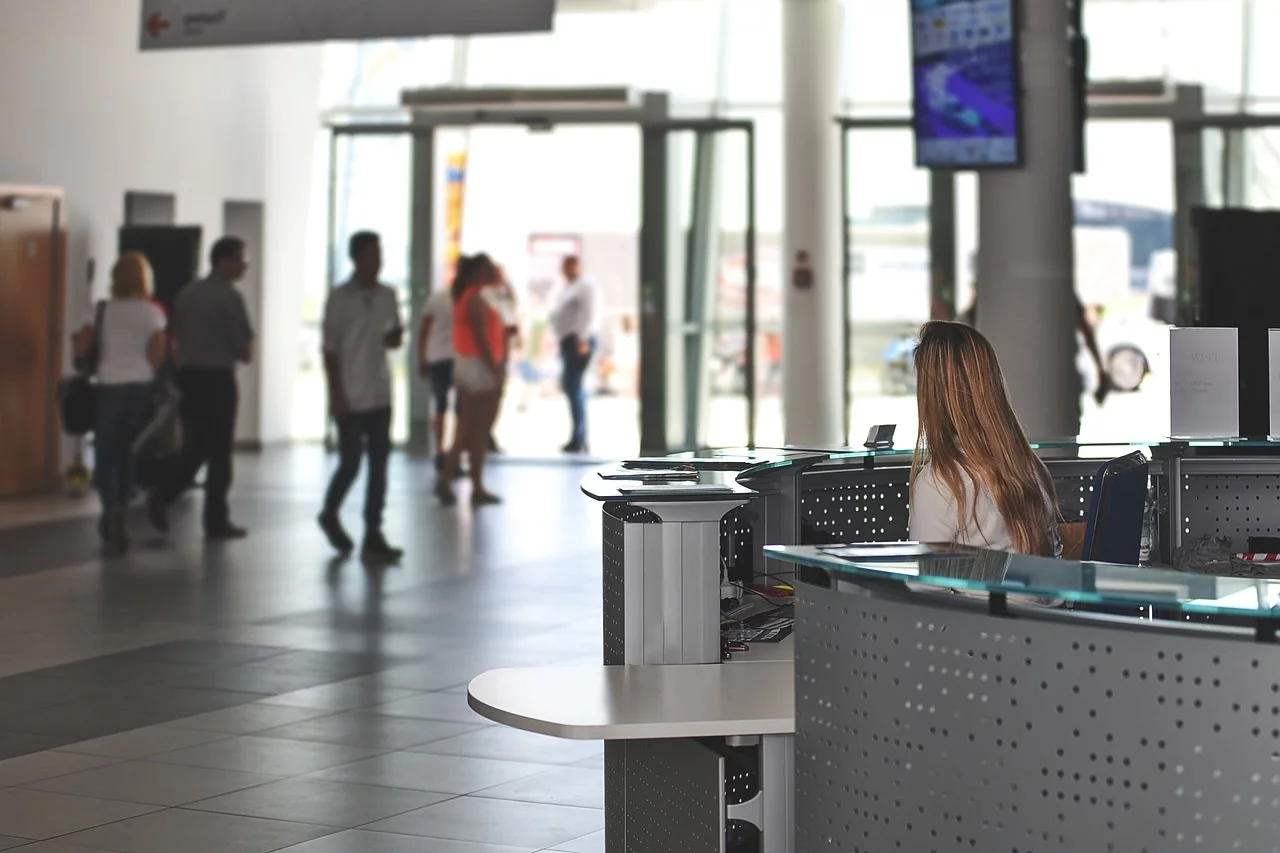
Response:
[141,0,556,50]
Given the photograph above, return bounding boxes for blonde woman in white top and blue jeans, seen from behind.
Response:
[74,252,166,556]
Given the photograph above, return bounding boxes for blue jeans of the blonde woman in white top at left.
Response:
[93,382,152,512]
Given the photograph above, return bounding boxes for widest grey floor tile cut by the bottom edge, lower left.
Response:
[61,808,334,853]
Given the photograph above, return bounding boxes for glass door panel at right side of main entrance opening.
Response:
[640,119,752,453]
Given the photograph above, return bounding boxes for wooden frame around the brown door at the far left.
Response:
[0,184,65,491]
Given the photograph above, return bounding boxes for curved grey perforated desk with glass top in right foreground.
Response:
[776,540,1280,853]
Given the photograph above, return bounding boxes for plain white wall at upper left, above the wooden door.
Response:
[0,0,324,442]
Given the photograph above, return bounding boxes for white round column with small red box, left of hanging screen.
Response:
[782,0,845,446]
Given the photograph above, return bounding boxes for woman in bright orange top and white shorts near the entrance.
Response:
[435,254,507,506]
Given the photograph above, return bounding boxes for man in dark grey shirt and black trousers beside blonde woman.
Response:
[147,237,253,542]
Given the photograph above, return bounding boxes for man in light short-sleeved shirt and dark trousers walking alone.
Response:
[319,231,404,562]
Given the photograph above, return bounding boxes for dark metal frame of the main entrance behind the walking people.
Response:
[326,90,758,455]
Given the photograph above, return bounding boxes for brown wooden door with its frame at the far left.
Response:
[0,187,64,497]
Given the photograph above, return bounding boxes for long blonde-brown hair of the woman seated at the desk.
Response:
[911,321,1059,555]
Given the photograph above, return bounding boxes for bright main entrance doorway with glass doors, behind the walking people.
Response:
[325,91,758,456]
